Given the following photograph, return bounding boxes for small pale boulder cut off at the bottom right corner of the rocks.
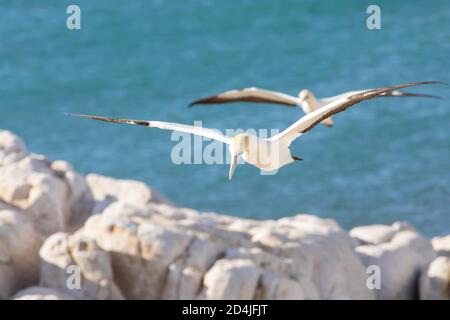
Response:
[420,257,450,300]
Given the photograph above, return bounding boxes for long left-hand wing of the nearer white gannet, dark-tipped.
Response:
[68,113,231,144]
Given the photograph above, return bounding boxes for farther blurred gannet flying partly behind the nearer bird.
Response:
[189,87,437,127]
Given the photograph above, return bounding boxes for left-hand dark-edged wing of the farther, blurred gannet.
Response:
[189,87,298,107]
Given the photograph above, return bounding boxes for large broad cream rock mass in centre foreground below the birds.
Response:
[35,202,373,299]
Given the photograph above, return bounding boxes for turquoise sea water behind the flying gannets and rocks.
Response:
[0,0,450,235]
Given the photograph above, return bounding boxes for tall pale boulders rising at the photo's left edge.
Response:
[0,131,70,298]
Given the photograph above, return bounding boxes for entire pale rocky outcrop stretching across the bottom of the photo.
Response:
[0,131,448,299]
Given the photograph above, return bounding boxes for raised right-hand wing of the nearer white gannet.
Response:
[270,81,440,145]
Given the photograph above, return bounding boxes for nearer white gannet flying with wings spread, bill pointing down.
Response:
[69,81,439,179]
